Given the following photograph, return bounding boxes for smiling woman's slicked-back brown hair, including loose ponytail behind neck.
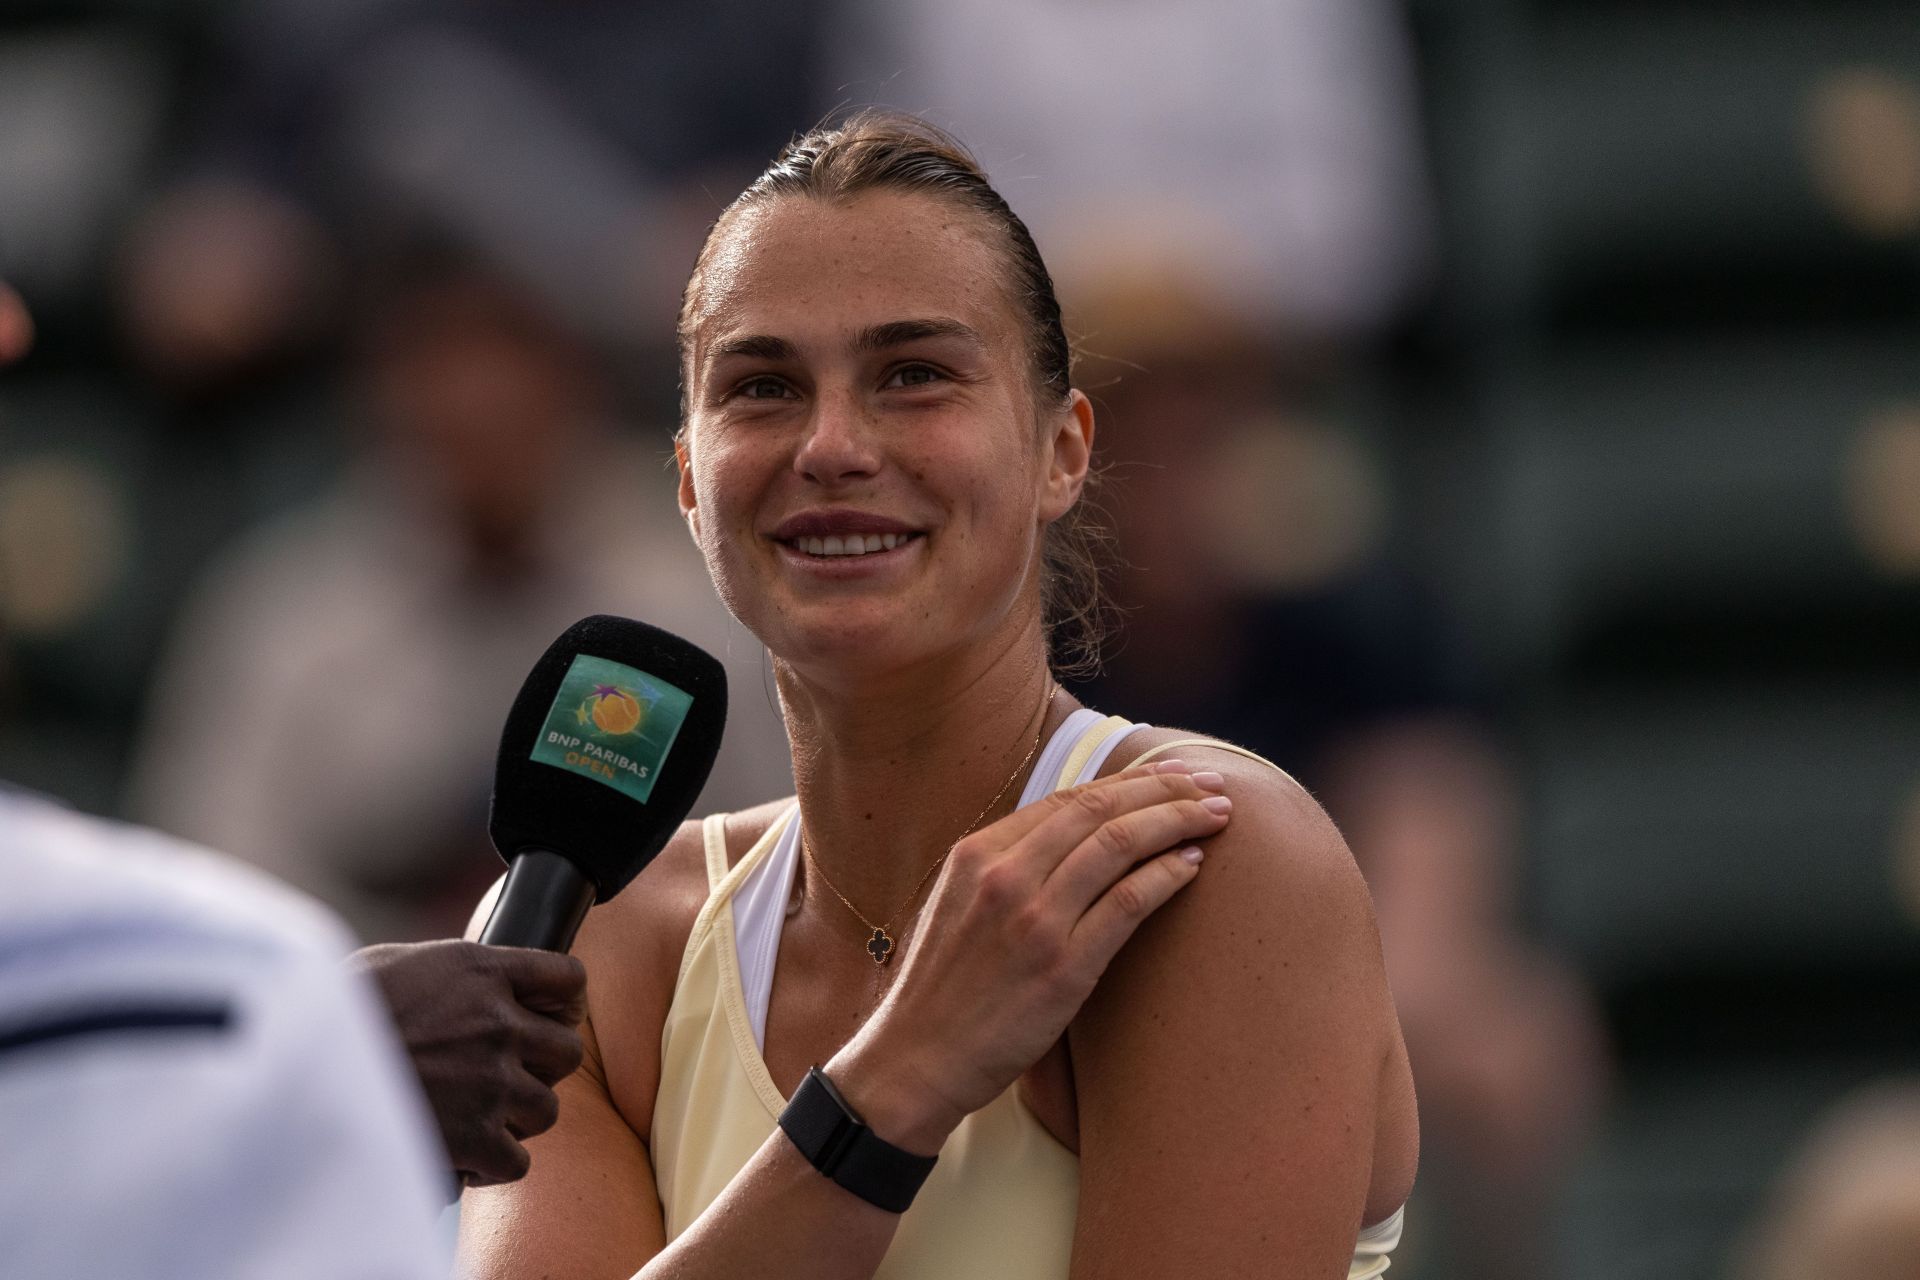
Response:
[676,109,1114,677]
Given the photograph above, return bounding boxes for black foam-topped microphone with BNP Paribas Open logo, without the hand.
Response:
[480,614,726,952]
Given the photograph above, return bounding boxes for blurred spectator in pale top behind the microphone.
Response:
[132,249,787,940]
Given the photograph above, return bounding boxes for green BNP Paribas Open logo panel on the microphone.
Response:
[532,652,693,804]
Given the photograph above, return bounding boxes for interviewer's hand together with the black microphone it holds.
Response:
[368,614,726,1186]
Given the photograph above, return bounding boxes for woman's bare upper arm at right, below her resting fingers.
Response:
[1069,747,1417,1280]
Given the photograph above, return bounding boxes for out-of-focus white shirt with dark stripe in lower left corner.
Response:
[0,791,449,1280]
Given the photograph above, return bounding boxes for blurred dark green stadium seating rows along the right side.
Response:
[1404,0,1920,1280]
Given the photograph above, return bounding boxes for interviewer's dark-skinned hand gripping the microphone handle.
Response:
[348,940,588,1186]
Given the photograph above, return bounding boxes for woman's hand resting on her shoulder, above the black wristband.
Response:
[828,760,1233,1153]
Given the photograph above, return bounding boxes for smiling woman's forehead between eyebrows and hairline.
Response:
[693,192,1020,361]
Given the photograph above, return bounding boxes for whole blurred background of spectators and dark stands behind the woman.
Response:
[0,0,1920,1280]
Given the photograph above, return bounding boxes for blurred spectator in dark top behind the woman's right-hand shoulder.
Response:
[1068,264,1605,1278]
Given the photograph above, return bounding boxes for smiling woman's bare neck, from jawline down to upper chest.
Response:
[776,629,1073,923]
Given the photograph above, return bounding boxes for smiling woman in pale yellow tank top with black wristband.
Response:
[463,115,1417,1280]
